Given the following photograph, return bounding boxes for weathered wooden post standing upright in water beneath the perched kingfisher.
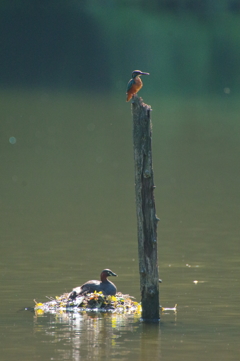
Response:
[132,95,159,321]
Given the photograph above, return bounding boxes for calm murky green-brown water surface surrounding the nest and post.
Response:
[0,91,240,361]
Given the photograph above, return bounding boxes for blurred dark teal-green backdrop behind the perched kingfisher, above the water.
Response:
[0,0,240,95]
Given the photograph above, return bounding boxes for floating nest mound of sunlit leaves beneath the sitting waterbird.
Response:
[34,291,142,315]
